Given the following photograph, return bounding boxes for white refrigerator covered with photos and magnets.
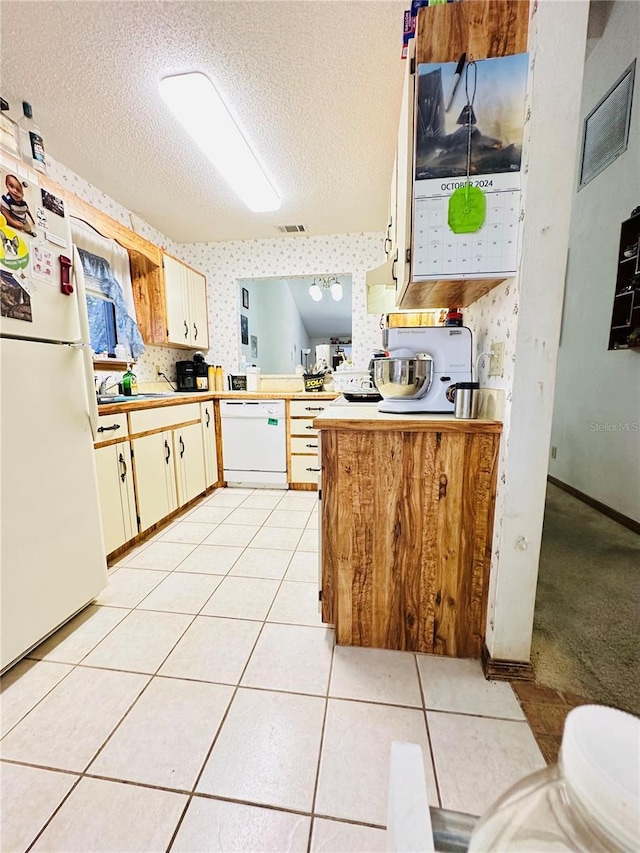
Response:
[0,156,107,671]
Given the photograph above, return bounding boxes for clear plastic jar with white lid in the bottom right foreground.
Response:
[469,705,640,853]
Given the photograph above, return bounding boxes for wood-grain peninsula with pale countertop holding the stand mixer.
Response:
[313,404,502,657]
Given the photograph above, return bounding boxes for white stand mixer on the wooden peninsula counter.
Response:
[376,326,472,415]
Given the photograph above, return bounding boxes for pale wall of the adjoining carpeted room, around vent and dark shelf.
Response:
[549,0,640,521]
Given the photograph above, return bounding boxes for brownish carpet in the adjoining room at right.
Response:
[532,484,640,715]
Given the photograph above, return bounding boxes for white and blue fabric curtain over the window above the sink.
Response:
[71,217,144,359]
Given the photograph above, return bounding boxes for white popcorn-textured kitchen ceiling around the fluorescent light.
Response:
[0,0,408,242]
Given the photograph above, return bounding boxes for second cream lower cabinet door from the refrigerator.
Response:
[131,432,179,532]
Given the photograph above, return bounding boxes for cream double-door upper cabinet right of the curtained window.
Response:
[163,255,209,350]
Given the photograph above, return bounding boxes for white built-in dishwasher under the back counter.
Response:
[220,400,287,489]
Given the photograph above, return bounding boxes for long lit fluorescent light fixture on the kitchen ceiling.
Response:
[159,71,281,213]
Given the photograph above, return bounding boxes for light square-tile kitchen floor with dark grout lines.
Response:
[0,489,545,853]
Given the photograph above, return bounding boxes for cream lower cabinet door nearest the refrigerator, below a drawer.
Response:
[95,441,138,554]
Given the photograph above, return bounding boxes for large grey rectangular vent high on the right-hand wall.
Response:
[579,59,636,189]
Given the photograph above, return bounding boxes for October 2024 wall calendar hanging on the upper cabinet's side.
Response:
[411,54,528,281]
